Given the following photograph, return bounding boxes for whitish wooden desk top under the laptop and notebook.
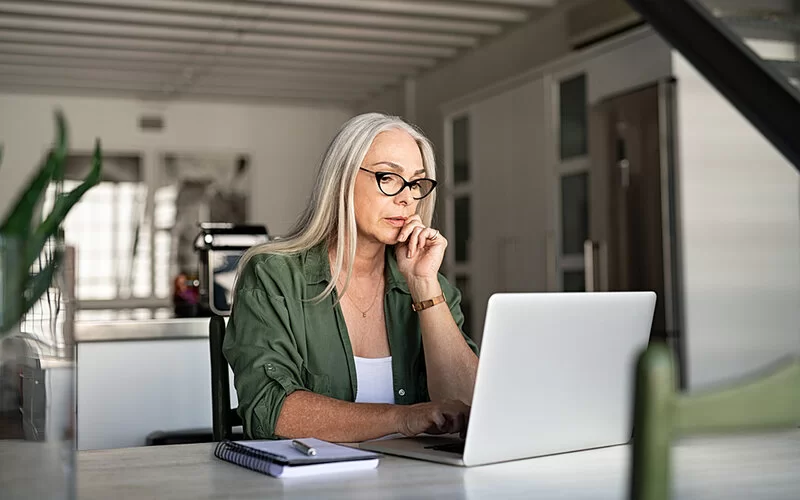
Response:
[78,430,800,500]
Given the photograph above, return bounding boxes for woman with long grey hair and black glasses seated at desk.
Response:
[223,113,478,442]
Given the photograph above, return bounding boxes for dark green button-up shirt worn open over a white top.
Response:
[223,244,478,439]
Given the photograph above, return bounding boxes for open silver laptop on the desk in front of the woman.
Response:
[361,292,656,466]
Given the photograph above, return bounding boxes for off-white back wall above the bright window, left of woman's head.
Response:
[0,94,351,235]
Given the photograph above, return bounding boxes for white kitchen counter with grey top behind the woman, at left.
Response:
[75,318,238,450]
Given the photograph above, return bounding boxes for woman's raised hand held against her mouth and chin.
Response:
[395,214,447,283]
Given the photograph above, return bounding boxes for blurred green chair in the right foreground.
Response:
[630,343,800,500]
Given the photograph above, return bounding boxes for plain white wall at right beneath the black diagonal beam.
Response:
[673,46,800,389]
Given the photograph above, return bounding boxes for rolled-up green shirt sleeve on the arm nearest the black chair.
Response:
[223,264,303,439]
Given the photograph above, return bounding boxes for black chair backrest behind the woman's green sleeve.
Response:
[208,315,242,441]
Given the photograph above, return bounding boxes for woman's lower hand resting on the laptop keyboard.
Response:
[396,399,470,437]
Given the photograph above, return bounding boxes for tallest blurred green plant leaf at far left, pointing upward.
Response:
[0,112,68,236]
